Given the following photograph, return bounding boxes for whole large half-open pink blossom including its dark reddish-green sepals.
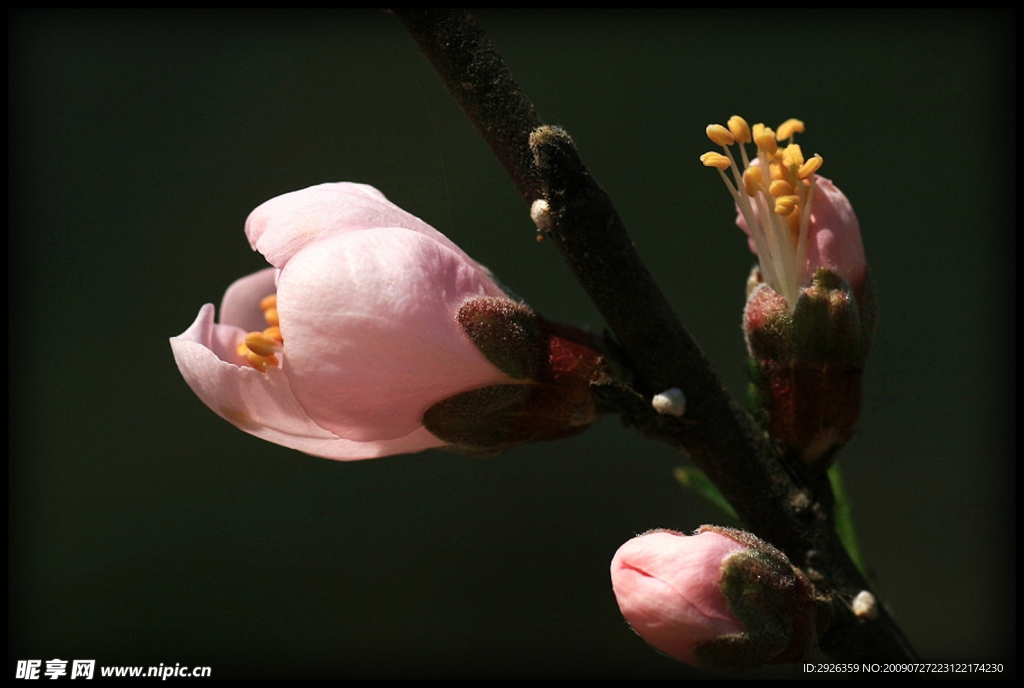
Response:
[171,183,605,460]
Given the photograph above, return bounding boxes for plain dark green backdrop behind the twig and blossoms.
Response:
[8,10,1016,678]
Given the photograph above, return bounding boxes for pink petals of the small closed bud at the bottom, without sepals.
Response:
[611,530,745,667]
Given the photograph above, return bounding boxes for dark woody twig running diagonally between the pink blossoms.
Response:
[391,9,915,661]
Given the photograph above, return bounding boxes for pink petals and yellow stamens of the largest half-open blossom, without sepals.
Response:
[171,183,522,460]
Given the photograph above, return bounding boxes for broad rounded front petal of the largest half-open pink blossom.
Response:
[278,228,510,440]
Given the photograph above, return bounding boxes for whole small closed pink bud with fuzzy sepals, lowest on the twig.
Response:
[611,525,816,671]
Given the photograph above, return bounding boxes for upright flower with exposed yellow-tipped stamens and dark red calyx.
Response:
[706,120,877,470]
